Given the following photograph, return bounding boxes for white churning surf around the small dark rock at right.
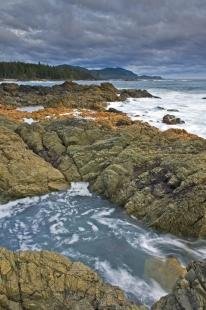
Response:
[108,89,206,138]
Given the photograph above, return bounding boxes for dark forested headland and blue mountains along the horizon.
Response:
[0,62,161,81]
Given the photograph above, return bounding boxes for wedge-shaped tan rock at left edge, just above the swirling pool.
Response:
[0,127,68,202]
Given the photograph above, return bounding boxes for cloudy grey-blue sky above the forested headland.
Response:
[0,0,206,78]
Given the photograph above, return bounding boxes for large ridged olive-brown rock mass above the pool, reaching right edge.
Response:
[17,119,206,238]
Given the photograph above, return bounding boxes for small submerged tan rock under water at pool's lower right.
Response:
[145,257,186,292]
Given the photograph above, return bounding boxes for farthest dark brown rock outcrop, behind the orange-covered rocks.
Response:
[0,81,153,110]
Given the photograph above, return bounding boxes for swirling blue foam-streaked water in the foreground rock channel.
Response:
[0,183,206,305]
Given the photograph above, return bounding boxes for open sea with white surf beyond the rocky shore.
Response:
[2,79,206,138]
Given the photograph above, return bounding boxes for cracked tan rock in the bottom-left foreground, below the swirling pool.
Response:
[0,248,143,310]
